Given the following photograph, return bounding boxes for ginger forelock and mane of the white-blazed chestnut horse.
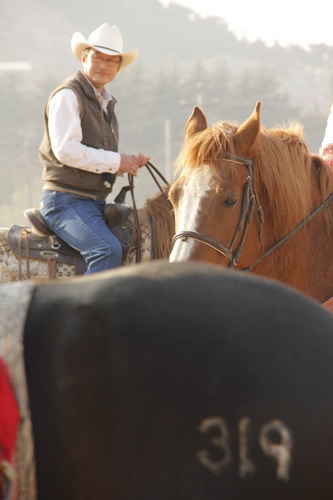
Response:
[176,122,333,235]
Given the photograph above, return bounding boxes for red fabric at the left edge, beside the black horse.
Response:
[0,358,20,491]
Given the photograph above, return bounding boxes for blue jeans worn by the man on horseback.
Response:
[40,190,122,274]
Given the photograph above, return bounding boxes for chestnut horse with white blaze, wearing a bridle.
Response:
[169,103,333,302]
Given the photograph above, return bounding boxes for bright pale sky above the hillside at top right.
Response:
[160,0,333,47]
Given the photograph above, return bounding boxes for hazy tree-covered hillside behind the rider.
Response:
[0,0,333,225]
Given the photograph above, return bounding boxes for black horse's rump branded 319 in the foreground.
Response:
[19,261,333,500]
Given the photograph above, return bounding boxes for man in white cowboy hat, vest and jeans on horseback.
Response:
[39,23,149,274]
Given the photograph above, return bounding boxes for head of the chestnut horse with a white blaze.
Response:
[170,102,261,265]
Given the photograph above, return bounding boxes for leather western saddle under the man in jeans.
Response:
[7,186,138,278]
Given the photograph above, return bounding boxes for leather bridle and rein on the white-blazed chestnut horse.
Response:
[172,155,333,271]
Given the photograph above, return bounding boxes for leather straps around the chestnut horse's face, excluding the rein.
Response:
[172,154,264,267]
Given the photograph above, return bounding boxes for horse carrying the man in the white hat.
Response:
[0,186,175,283]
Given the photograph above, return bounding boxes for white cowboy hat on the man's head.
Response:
[71,23,138,70]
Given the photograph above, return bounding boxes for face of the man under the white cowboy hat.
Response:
[81,49,121,88]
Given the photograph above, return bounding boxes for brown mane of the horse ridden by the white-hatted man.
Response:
[145,187,175,259]
